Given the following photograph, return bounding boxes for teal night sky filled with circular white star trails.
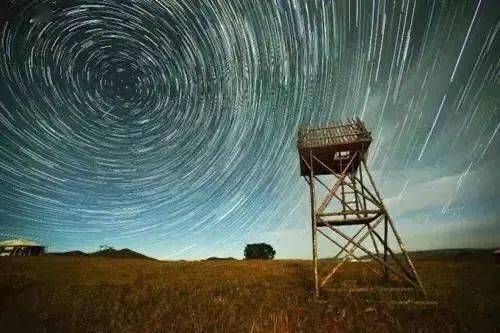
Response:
[0,0,500,259]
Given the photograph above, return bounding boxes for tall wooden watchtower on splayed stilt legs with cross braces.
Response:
[298,119,425,296]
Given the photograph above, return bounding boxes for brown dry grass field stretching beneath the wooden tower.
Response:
[0,257,500,332]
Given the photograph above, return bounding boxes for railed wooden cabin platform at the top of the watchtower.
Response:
[297,118,372,176]
